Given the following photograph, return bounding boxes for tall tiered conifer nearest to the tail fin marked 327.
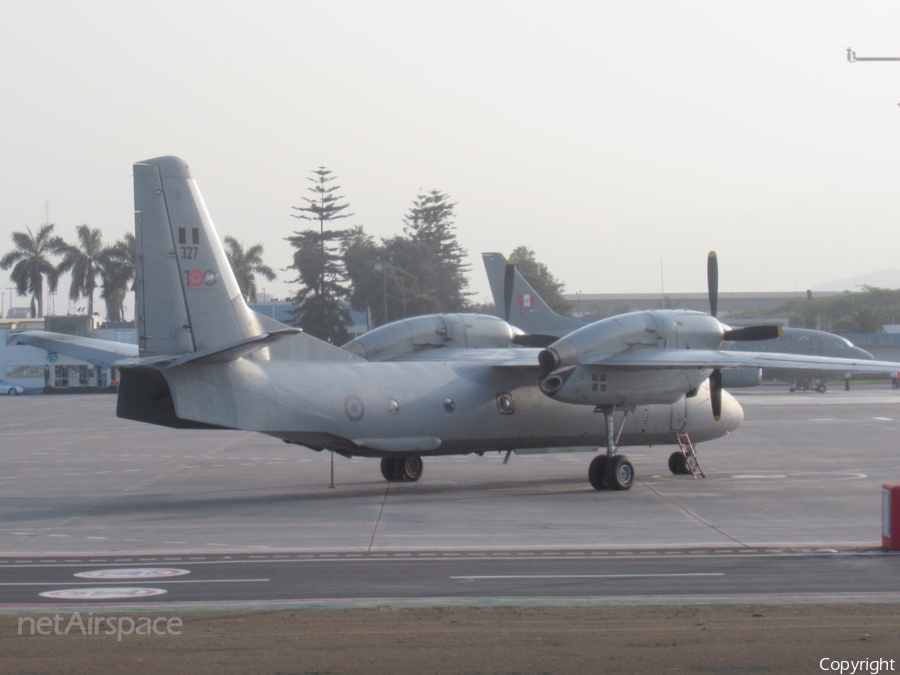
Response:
[287,166,353,344]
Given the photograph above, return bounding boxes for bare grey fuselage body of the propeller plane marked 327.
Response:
[156,359,743,457]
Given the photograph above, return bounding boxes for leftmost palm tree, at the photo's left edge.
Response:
[0,223,65,318]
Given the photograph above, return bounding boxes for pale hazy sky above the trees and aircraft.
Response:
[0,0,900,311]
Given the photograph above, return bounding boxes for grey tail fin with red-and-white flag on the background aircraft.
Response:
[481,253,583,336]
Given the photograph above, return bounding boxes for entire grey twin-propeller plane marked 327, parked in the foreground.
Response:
[15,157,895,490]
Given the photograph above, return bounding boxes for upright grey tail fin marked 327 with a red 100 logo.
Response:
[134,157,264,356]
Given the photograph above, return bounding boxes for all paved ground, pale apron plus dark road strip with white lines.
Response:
[0,385,900,608]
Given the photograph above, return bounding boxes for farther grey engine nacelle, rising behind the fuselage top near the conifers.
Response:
[343,314,521,361]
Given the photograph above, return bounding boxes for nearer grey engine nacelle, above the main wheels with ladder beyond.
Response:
[539,310,724,406]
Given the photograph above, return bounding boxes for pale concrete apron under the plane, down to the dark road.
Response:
[0,385,900,555]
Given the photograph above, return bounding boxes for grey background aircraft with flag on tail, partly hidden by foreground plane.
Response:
[481,253,876,394]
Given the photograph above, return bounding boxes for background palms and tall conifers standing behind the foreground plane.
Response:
[0,166,572,344]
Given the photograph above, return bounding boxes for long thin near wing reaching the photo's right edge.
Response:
[596,349,900,373]
